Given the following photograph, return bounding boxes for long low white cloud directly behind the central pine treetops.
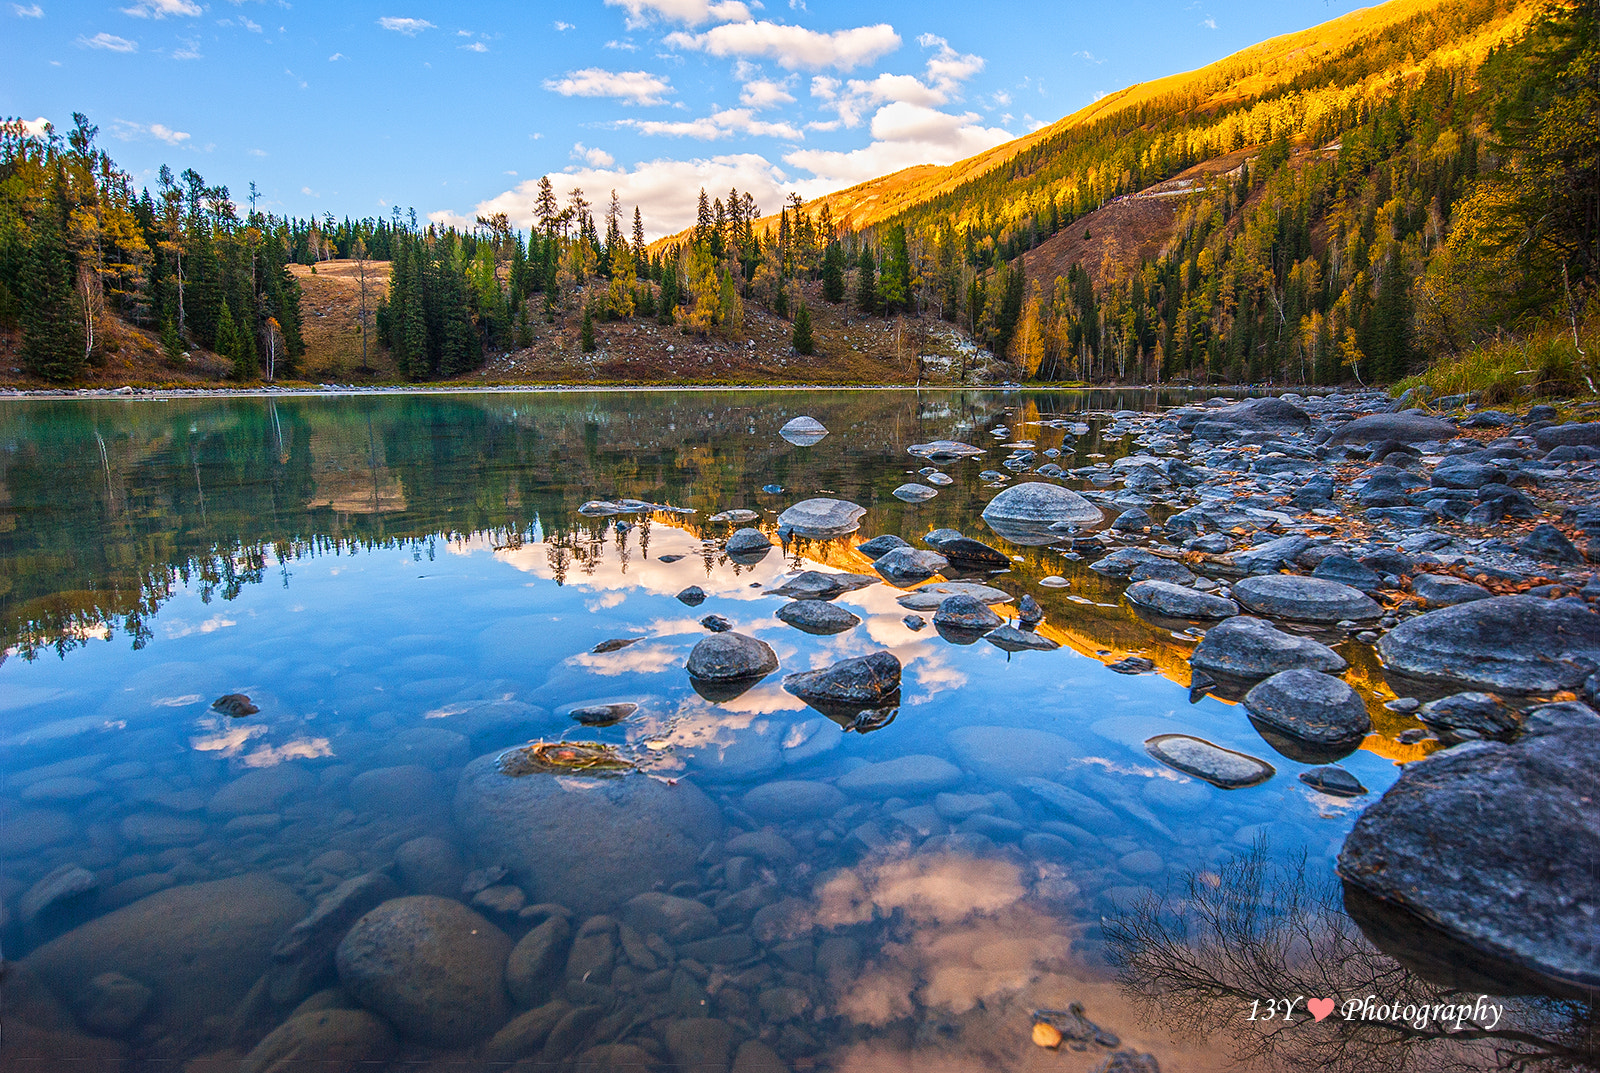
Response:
[474,154,792,238]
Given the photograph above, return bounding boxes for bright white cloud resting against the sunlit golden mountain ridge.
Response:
[784,101,1013,197]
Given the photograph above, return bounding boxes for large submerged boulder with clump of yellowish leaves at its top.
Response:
[454,755,722,923]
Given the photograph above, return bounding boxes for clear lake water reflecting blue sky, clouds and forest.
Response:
[0,392,1580,1071]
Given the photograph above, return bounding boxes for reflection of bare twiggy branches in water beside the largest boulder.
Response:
[1102,843,1600,1073]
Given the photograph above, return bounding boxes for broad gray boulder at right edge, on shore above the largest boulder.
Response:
[1378,596,1600,694]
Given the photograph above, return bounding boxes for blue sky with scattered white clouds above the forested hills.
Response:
[0,0,1357,237]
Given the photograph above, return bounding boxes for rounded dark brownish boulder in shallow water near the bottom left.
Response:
[334,894,510,1047]
